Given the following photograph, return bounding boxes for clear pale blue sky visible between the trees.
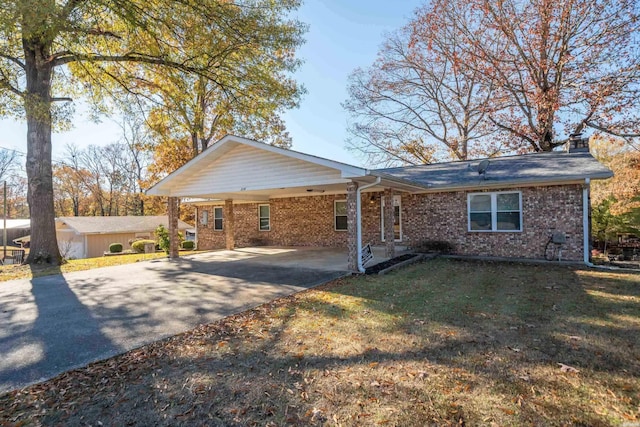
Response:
[0,0,420,166]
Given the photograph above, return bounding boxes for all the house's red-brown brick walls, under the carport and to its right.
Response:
[198,185,583,261]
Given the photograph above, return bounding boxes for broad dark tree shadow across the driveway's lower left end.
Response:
[0,275,124,392]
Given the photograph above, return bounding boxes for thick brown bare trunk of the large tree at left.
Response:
[23,40,61,265]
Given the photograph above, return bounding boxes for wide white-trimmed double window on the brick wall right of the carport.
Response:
[467,191,522,231]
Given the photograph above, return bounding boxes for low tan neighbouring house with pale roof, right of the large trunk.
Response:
[56,215,192,259]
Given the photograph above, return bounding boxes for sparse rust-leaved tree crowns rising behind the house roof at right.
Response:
[346,0,640,163]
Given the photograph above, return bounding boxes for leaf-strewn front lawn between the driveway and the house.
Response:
[0,259,640,426]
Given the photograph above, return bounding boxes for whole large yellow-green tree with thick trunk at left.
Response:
[0,0,304,263]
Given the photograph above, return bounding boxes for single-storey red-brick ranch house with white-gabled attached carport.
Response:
[147,135,612,272]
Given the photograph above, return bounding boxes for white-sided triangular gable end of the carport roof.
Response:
[172,144,349,196]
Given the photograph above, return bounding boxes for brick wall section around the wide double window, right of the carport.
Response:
[402,185,583,261]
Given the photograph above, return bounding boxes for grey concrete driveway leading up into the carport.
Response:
[0,248,346,392]
